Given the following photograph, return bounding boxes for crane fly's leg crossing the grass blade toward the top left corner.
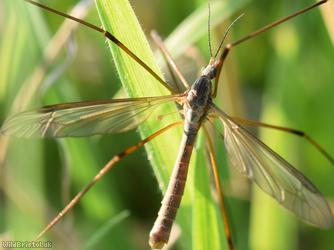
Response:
[24,0,176,94]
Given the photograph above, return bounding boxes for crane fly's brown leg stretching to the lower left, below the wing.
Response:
[34,121,183,241]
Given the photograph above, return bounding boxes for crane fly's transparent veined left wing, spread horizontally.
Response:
[1,95,181,137]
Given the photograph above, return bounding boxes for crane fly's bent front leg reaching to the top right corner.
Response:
[212,0,328,97]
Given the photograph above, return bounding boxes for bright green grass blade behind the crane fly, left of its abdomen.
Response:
[96,0,182,189]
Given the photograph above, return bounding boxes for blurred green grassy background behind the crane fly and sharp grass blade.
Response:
[0,0,334,250]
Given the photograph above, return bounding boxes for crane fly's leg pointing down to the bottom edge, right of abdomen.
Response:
[203,126,234,250]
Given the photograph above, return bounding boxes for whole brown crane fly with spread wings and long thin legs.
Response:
[1,0,334,249]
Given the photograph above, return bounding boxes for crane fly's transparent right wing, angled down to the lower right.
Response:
[212,105,333,228]
